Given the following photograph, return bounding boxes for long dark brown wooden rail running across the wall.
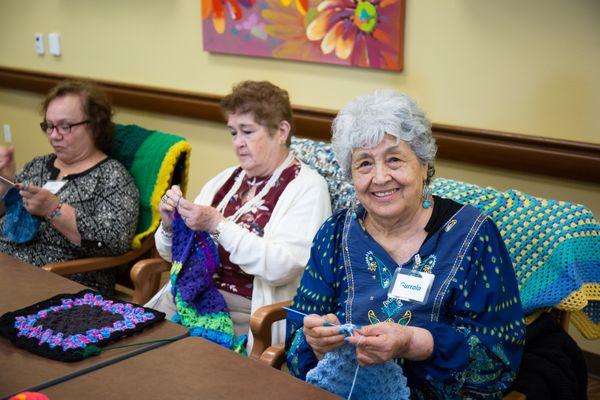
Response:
[0,67,600,183]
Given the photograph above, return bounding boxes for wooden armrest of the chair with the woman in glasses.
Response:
[42,237,154,276]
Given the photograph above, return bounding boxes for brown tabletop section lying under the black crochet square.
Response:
[0,253,188,398]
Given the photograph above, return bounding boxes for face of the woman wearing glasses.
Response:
[46,94,96,164]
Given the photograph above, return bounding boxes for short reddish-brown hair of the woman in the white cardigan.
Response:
[221,81,295,146]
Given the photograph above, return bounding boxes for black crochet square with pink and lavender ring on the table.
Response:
[0,289,165,362]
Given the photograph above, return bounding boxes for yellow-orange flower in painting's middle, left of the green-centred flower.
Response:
[261,0,323,60]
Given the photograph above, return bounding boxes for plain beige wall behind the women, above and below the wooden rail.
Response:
[0,0,600,353]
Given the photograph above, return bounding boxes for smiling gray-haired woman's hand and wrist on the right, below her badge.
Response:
[348,322,433,366]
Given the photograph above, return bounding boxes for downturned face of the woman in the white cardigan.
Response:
[227,113,289,176]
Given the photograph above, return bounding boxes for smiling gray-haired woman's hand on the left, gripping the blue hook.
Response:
[304,314,346,360]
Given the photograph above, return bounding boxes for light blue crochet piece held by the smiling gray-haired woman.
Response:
[306,324,410,400]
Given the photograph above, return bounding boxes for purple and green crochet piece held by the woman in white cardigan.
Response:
[171,213,247,353]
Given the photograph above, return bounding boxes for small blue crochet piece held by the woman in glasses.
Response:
[2,187,42,244]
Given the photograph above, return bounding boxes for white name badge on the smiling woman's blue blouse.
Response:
[388,268,435,303]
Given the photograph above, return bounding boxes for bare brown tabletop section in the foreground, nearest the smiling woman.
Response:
[41,337,340,400]
